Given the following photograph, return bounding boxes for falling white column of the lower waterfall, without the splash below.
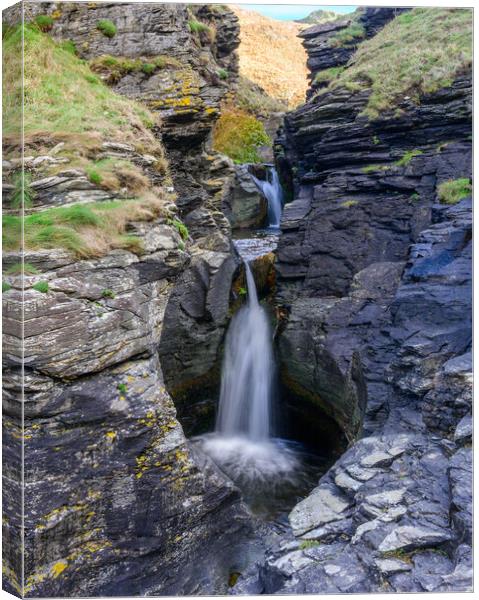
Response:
[216,262,273,441]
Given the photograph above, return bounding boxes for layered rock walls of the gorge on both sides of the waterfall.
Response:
[3,3,472,596]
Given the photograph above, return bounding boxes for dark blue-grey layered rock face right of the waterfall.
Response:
[235,4,472,594]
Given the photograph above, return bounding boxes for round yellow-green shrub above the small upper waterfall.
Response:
[213,108,271,163]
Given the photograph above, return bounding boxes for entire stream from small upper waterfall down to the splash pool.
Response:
[195,168,327,526]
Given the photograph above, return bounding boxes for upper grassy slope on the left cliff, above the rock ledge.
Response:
[3,25,159,148]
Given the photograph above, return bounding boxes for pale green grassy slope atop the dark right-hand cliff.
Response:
[330,8,472,118]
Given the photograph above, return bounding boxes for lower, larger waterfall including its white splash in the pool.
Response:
[196,262,322,518]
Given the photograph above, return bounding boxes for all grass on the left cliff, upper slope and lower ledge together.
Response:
[3,24,171,257]
